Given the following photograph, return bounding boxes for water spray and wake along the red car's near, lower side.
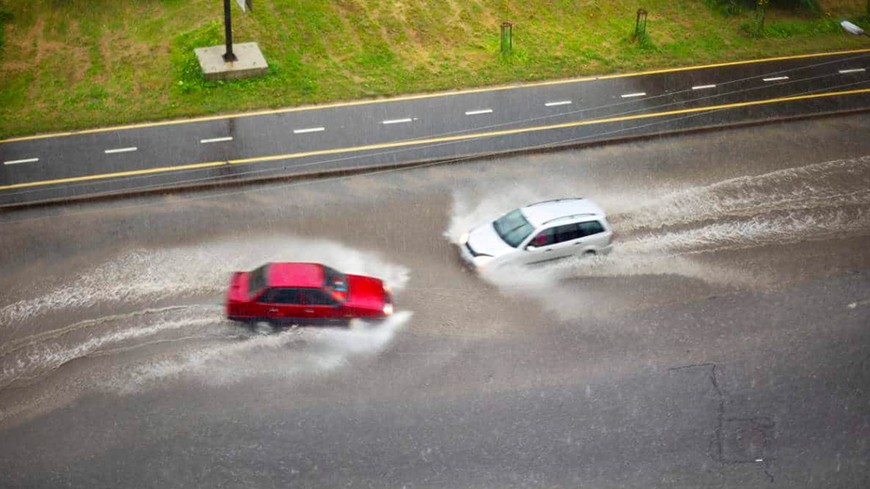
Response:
[0,311,412,423]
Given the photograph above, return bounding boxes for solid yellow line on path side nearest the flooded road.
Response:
[0,88,870,191]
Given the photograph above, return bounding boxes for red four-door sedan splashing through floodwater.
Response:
[226,263,393,325]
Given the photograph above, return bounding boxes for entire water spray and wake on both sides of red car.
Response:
[0,237,411,428]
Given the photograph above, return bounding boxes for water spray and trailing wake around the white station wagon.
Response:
[444,156,870,291]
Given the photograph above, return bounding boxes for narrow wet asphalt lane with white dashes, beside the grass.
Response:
[0,50,870,207]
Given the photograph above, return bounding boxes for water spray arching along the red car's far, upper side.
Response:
[0,237,409,326]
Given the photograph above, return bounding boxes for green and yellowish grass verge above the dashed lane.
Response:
[0,0,870,138]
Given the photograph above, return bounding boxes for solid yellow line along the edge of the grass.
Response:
[0,49,870,144]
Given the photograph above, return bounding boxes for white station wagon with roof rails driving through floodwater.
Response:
[459,198,613,271]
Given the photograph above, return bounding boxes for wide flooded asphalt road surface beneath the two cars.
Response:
[0,115,870,489]
